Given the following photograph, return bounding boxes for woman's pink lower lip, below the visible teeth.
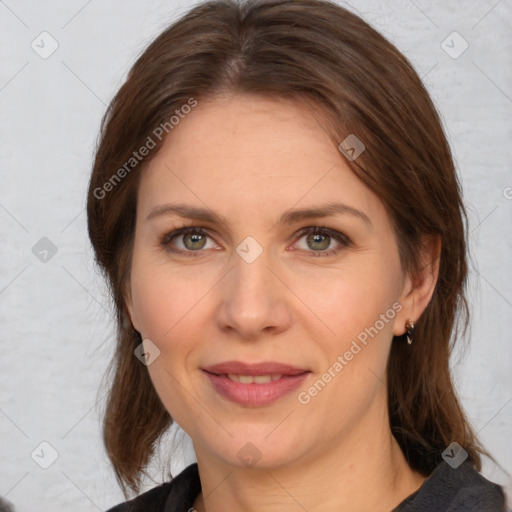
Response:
[204,372,310,407]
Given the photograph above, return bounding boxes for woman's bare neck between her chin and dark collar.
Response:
[194,412,425,512]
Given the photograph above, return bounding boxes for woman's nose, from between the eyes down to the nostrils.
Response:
[216,244,292,341]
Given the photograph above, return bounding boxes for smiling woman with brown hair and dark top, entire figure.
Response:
[88,0,505,512]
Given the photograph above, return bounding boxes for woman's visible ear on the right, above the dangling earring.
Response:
[393,235,441,336]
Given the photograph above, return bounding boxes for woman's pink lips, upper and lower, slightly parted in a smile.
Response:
[202,361,311,407]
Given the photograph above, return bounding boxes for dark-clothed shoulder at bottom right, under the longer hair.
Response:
[394,461,505,512]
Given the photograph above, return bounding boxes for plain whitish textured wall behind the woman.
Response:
[0,0,512,512]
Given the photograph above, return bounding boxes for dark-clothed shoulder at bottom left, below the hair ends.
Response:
[107,463,201,512]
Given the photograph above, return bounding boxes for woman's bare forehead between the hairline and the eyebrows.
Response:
[139,96,382,226]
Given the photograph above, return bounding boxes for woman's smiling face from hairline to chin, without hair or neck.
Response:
[128,96,407,467]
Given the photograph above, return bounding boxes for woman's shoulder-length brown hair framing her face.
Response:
[87,0,488,495]
